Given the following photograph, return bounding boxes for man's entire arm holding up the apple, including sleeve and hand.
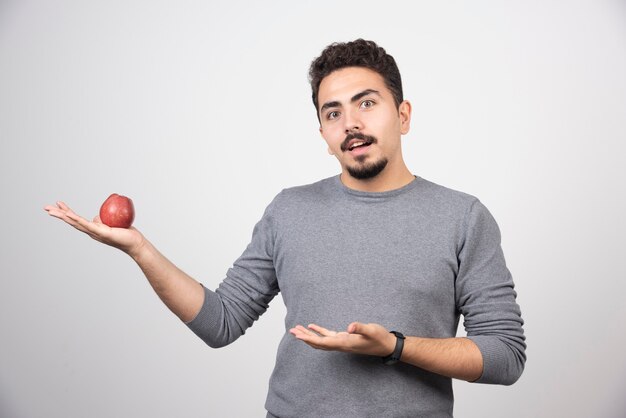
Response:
[44,197,279,348]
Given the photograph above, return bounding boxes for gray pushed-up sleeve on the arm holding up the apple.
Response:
[187,194,279,348]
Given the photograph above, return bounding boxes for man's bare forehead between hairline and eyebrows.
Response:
[318,67,391,106]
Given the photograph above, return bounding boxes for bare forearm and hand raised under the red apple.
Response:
[44,202,204,321]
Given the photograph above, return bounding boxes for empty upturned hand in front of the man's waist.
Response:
[289,322,396,357]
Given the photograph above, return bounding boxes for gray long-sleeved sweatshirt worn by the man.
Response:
[187,176,526,417]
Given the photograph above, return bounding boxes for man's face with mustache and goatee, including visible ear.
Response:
[318,67,411,180]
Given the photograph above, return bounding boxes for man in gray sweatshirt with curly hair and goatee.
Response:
[46,39,526,417]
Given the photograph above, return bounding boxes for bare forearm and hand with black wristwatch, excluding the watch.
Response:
[290,322,483,381]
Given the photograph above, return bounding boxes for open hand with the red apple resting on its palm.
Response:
[44,202,145,257]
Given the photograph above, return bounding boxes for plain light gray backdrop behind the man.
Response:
[0,0,626,417]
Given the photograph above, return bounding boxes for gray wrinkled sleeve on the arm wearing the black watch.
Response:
[455,200,526,385]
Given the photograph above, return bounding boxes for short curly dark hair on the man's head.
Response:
[309,39,404,120]
